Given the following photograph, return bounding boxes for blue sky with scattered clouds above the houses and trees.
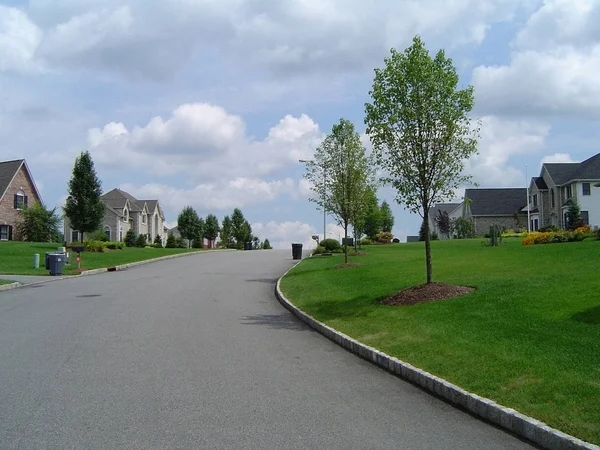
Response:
[0,0,600,248]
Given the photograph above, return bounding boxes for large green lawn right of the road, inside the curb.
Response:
[281,239,600,444]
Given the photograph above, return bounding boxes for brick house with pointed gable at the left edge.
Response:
[0,159,42,241]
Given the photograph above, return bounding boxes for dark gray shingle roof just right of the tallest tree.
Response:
[465,188,527,216]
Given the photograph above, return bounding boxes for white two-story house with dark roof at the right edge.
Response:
[529,153,600,230]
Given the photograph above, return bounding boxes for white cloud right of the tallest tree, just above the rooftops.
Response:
[465,116,550,187]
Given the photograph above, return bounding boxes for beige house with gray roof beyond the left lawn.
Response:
[65,188,167,245]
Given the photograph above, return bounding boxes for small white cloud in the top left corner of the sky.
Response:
[0,5,42,72]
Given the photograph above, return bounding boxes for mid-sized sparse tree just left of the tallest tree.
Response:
[305,119,370,263]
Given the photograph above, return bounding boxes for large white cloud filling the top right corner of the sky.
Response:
[473,0,600,119]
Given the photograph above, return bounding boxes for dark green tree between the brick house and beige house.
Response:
[63,152,104,242]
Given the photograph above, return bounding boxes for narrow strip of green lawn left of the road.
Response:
[0,241,204,275]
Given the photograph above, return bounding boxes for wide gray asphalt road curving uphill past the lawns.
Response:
[0,251,533,450]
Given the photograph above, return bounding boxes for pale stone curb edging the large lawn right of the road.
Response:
[275,261,600,450]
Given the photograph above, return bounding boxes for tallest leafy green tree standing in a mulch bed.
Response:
[365,36,479,283]
